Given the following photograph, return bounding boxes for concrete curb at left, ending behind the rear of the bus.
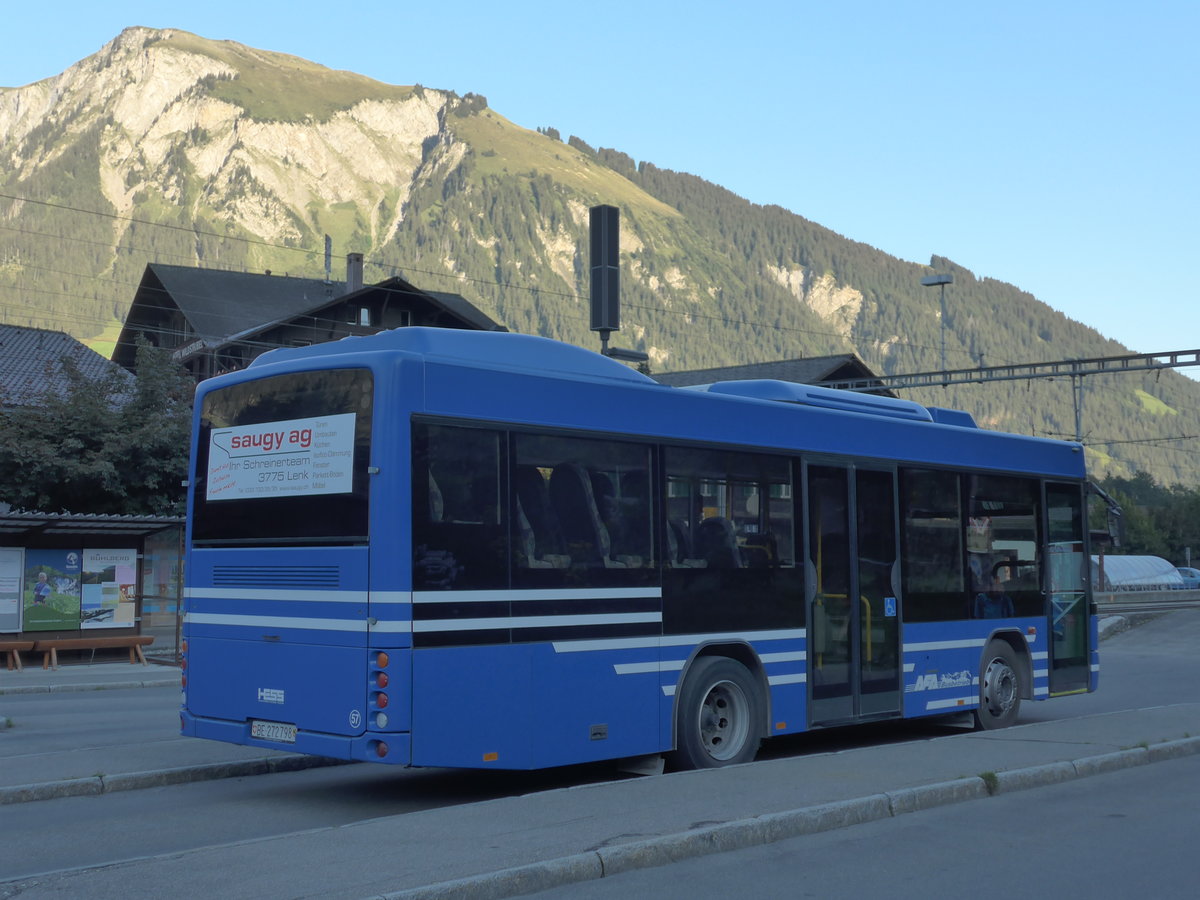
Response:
[0,756,348,806]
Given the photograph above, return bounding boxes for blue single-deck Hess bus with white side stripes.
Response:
[182,328,1098,769]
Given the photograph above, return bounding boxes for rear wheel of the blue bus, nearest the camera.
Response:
[671,656,763,769]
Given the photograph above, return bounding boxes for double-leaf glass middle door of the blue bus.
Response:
[806,466,900,725]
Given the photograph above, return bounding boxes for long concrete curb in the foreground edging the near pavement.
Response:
[366,738,1200,900]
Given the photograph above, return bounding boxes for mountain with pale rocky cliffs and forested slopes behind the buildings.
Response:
[0,29,1200,486]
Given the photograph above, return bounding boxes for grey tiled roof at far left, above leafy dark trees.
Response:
[0,325,130,406]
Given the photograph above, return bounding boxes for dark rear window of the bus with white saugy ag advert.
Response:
[192,368,372,545]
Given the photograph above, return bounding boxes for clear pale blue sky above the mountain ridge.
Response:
[0,0,1200,367]
